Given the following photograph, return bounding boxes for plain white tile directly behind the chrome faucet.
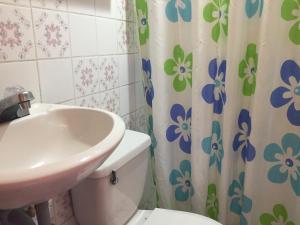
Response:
[0,61,40,102]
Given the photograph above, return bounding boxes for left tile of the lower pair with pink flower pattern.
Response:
[73,57,99,97]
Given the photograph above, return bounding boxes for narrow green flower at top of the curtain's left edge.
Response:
[136,0,149,45]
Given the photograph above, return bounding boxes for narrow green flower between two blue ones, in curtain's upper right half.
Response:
[239,43,258,96]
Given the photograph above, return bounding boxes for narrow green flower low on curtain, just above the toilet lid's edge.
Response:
[206,184,219,220]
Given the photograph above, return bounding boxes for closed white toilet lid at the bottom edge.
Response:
[144,209,222,225]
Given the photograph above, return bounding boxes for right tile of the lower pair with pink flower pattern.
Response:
[99,56,119,91]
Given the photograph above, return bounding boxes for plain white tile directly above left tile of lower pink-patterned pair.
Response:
[70,14,97,56]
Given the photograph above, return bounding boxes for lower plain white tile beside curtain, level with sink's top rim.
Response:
[120,84,135,115]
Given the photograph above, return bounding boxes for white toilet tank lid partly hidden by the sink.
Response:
[88,130,151,179]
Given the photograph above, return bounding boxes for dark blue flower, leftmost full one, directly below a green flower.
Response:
[166,104,192,154]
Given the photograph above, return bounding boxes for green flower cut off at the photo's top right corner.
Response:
[281,0,300,45]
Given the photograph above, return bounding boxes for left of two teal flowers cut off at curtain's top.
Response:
[166,0,192,22]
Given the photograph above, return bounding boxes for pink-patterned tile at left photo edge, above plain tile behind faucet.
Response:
[0,4,35,61]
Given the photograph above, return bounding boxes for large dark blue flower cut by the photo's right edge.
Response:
[270,60,300,126]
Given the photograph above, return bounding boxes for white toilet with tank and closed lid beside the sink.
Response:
[71,130,221,225]
